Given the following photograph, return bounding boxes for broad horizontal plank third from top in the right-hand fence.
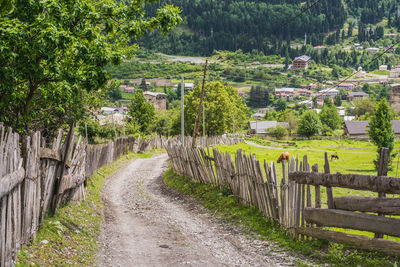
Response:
[304,208,400,237]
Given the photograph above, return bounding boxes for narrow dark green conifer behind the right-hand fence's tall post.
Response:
[368,99,395,169]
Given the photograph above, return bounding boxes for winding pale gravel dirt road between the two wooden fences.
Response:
[98,155,295,266]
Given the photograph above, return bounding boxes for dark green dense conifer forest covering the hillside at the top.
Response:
[141,0,400,55]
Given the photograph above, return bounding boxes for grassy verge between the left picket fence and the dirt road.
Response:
[16,153,152,266]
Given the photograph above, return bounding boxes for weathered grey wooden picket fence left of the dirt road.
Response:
[0,125,162,266]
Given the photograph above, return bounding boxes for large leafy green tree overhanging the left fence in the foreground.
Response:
[0,0,181,134]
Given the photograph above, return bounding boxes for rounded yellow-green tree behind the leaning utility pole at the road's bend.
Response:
[185,82,248,136]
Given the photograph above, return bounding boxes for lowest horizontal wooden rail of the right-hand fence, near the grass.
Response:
[297,228,400,256]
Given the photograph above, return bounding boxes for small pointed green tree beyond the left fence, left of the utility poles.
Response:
[128,89,155,134]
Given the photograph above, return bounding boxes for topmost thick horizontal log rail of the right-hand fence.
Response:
[289,172,400,194]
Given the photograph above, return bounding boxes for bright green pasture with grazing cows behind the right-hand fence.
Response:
[218,139,400,241]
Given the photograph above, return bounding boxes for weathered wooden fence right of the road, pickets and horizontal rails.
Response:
[166,142,400,256]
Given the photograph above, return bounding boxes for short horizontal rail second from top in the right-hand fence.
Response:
[333,196,400,215]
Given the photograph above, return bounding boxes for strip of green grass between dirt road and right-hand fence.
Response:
[164,168,399,266]
